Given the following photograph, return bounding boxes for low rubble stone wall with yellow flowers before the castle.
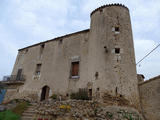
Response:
[34,100,143,120]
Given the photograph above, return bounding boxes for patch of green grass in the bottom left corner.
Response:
[0,110,20,120]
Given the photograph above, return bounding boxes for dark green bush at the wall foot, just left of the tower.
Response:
[70,89,89,100]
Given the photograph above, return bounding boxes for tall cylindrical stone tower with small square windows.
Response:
[88,4,139,106]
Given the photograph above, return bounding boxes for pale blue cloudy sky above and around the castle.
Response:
[0,0,160,79]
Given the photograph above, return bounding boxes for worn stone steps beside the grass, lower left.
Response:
[21,104,36,120]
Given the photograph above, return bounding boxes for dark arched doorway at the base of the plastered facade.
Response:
[41,86,50,101]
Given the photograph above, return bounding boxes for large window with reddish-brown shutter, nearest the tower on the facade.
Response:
[71,61,79,78]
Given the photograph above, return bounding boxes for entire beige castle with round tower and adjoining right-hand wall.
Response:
[1,4,160,120]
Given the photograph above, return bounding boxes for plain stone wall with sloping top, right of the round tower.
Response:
[139,76,160,120]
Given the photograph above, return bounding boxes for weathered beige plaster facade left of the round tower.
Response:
[3,30,89,101]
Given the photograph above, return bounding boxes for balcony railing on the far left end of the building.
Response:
[2,75,25,83]
